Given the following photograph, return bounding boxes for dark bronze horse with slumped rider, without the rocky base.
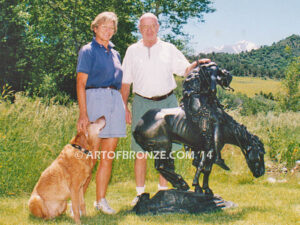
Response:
[133,63,265,195]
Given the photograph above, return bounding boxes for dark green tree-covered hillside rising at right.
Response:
[190,35,300,79]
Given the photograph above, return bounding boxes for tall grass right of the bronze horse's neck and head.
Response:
[235,112,300,167]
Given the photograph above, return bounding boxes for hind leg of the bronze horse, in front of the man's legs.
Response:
[155,150,190,191]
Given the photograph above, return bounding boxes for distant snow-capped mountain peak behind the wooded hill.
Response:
[201,40,259,54]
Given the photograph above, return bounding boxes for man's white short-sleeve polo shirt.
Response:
[122,39,190,98]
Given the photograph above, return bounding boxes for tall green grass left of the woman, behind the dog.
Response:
[0,94,77,194]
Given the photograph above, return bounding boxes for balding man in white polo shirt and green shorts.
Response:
[121,13,210,205]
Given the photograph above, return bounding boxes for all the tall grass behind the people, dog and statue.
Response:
[0,94,300,195]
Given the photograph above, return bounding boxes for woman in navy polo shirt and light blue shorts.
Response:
[77,12,126,214]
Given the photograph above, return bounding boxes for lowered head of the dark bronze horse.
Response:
[243,135,265,177]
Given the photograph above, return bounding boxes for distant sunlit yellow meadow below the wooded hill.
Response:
[231,77,281,97]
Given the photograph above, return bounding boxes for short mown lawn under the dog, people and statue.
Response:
[0,146,300,225]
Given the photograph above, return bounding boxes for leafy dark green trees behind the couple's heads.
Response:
[0,0,213,101]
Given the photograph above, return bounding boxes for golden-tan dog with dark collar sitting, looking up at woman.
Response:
[28,116,105,223]
